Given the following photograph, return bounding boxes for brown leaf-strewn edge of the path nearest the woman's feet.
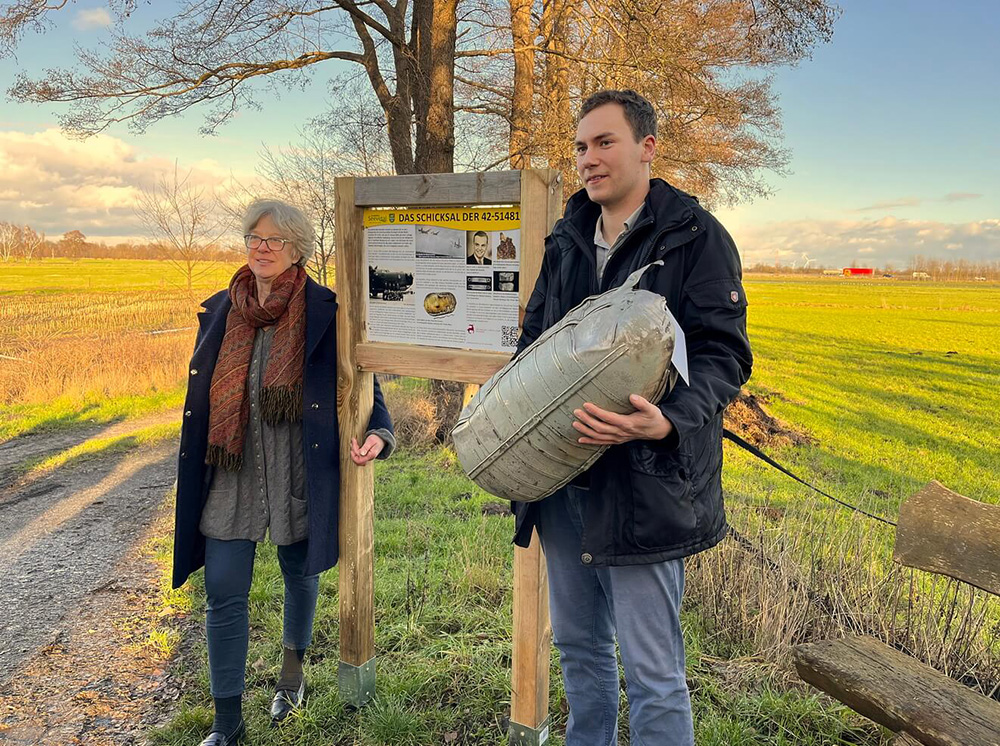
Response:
[0,494,195,746]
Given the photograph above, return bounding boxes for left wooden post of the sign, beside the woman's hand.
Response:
[334,178,375,707]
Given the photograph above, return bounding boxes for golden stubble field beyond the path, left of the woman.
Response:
[0,259,242,440]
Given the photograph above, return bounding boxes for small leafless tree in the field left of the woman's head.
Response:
[134,163,229,296]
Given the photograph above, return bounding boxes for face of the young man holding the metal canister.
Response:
[574,103,656,208]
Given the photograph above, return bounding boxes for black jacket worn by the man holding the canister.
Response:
[514,179,752,565]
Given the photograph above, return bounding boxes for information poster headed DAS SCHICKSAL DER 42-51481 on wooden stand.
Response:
[364,207,521,352]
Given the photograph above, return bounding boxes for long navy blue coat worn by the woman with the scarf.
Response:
[173,279,392,588]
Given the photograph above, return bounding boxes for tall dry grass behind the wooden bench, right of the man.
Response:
[687,454,1000,696]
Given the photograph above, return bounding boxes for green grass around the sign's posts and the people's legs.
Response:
[154,449,877,746]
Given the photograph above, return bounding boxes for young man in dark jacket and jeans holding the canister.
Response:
[514,90,752,746]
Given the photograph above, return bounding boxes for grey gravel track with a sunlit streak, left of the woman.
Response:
[0,413,177,696]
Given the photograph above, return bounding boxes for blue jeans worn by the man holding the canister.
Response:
[538,487,694,746]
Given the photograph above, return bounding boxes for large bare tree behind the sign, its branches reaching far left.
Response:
[0,0,458,173]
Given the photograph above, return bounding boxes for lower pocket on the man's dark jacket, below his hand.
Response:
[629,441,698,550]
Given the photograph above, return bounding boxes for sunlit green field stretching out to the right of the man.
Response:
[725,279,1000,515]
